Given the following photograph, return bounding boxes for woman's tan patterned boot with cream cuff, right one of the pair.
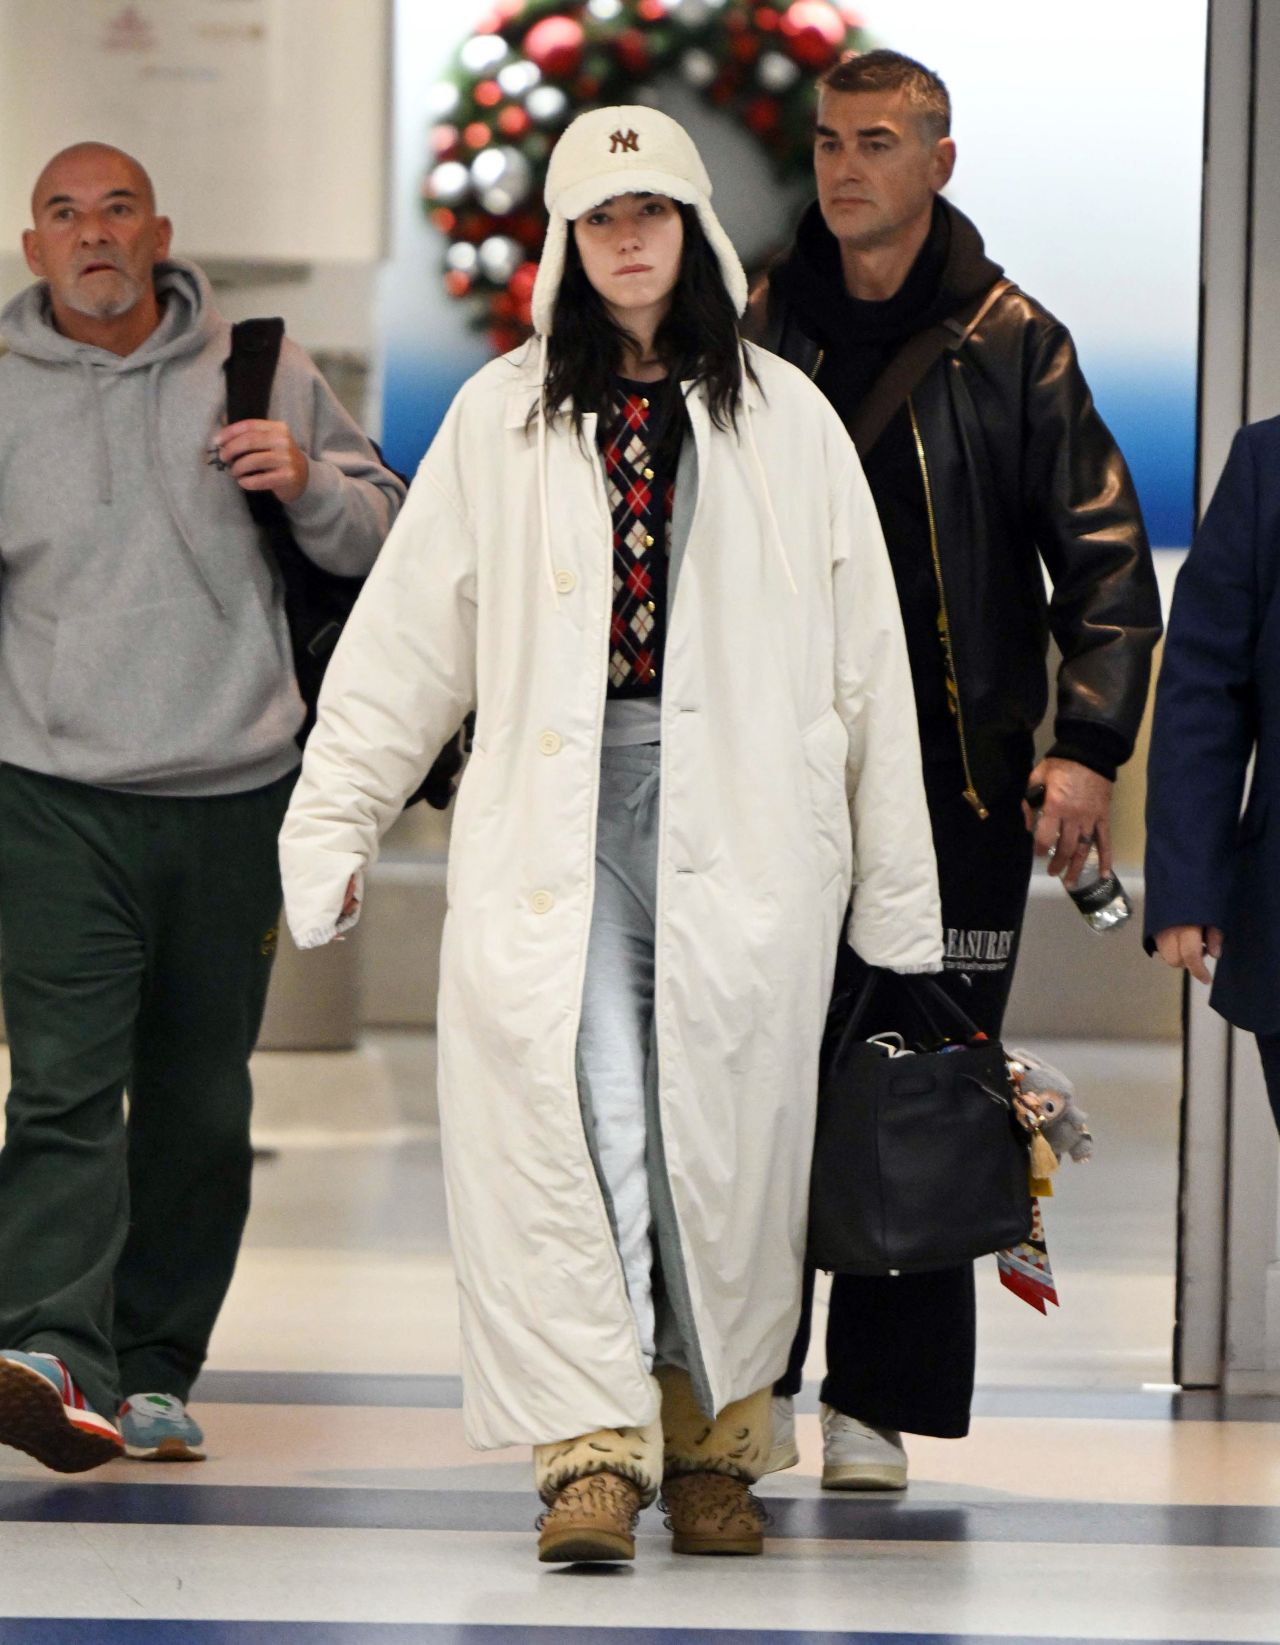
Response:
[656,1365,773,1555]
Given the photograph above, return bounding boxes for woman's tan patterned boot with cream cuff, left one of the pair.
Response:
[533,1423,661,1564]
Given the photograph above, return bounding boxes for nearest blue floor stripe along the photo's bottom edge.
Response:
[0,1625,1249,1645]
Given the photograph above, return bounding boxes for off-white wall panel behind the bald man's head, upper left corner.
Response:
[0,0,390,262]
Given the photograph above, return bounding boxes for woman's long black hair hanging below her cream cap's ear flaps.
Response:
[543,201,757,461]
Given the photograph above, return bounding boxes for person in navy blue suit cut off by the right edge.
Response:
[1145,418,1280,1125]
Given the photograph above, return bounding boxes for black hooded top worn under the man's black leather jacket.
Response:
[772,199,1002,783]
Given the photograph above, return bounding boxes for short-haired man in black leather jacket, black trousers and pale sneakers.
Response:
[747,51,1160,1489]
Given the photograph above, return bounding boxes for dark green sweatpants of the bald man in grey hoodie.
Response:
[0,767,294,1415]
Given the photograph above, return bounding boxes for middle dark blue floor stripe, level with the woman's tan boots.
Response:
[0,1481,1280,1548]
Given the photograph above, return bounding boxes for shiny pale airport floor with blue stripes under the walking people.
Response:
[9,1036,1280,1645]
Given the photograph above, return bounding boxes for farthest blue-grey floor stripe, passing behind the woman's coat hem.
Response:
[192,1370,1280,1423]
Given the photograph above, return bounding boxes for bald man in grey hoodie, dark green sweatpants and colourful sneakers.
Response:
[0,143,403,1472]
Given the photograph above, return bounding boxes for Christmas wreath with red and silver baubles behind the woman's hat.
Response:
[423,0,864,352]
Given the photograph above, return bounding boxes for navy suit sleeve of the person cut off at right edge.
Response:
[1145,429,1265,939]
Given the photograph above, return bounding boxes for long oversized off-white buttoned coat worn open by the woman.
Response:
[281,345,941,1448]
